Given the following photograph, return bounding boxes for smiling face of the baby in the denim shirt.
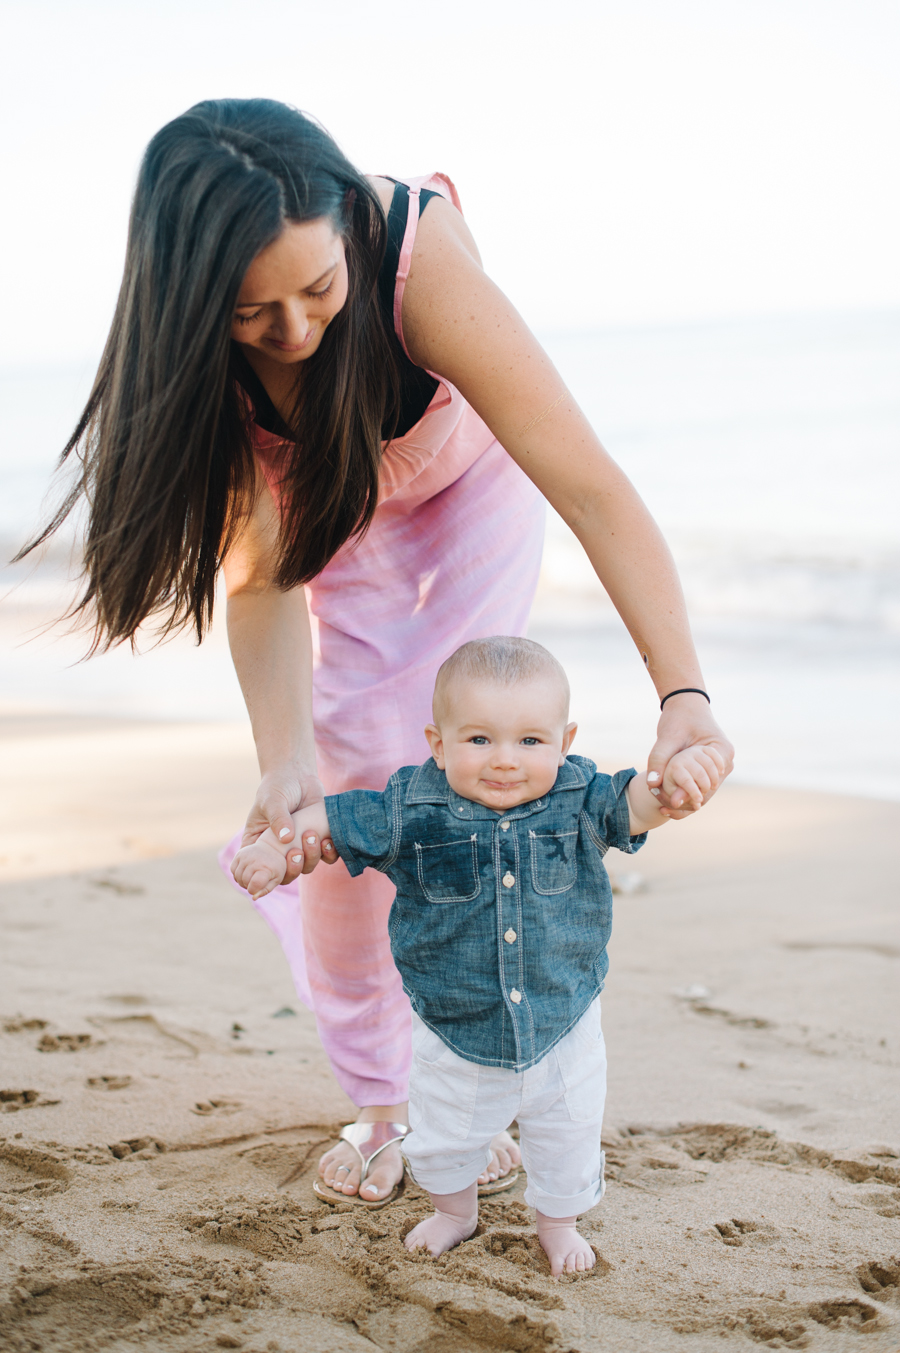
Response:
[425,677,575,813]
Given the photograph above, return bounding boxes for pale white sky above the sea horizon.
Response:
[0,0,900,367]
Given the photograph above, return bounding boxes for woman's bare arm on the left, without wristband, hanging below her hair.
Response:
[222,470,336,882]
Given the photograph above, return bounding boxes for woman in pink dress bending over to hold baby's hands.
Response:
[22,100,731,1204]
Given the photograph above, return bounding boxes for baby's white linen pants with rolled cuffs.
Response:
[403,997,606,1216]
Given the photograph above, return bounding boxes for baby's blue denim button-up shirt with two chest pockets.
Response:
[325,756,647,1072]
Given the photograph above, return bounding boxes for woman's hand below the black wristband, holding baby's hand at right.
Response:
[647,693,735,820]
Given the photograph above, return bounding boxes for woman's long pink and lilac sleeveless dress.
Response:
[219,175,544,1107]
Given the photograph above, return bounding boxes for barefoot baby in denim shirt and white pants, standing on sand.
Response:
[231,637,721,1277]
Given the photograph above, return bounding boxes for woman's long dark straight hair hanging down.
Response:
[18,99,398,652]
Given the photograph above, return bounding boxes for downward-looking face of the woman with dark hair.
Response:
[231,216,348,365]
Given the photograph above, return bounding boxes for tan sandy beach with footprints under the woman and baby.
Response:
[0,716,900,1353]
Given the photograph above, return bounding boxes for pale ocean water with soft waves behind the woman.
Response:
[0,311,900,798]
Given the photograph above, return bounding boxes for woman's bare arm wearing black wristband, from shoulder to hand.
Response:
[403,200,732,809]
